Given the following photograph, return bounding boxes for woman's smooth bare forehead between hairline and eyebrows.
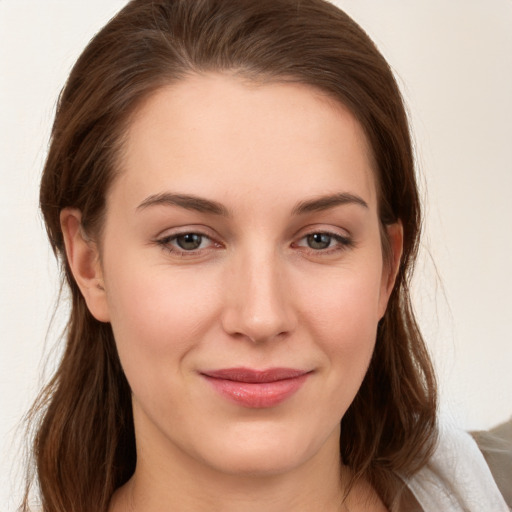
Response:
[119,74,376,211]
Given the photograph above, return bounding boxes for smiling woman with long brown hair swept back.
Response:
[21,0,505,512]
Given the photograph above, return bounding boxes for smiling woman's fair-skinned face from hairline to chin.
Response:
[84,74,401,474]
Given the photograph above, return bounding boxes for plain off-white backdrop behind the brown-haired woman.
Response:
[0,0,512,512]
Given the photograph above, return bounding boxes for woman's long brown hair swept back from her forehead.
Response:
[23,0,436,512]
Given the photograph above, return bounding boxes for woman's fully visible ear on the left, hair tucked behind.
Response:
[60,208,110,322]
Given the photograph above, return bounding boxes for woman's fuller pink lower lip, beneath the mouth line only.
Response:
[203,373,308,409]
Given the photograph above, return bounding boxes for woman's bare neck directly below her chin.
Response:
[110,433,350,512]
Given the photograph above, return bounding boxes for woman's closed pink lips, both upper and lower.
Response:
[202,368,310,408]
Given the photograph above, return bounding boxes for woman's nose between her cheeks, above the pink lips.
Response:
[222,251,297,342]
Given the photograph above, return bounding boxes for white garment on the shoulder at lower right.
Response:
[407,425,510,512]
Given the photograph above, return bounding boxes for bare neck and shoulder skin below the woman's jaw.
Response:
[110,415,386,512]
